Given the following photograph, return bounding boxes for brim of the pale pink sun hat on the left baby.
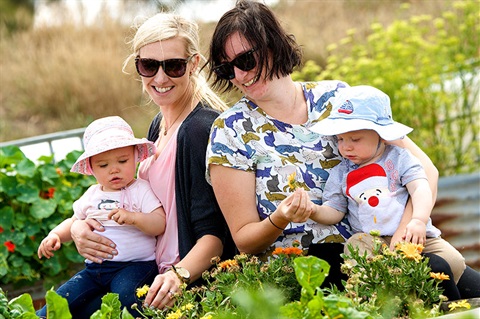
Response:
[70,138,157,175]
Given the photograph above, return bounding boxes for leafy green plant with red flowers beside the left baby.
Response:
[0,146,95,288]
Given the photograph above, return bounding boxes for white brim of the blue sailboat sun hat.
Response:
[310,118,413,141]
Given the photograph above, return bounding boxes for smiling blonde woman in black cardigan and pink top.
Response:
[72,13,235,316]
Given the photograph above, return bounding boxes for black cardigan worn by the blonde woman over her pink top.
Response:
[147,103,237,260]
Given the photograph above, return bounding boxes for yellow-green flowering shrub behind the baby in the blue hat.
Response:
[294,0,480,175]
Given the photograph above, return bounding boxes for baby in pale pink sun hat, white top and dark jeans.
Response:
[38,116,165,313]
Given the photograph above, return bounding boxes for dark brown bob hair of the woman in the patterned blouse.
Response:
[207,0,303,92]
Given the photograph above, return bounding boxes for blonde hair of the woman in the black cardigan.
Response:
[123,12,228,111]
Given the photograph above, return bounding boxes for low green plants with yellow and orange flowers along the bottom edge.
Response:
[0,243,470,319]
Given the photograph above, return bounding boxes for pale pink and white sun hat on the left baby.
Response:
[70,116,156,175]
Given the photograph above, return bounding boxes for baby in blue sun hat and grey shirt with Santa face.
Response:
[310,86,465,282]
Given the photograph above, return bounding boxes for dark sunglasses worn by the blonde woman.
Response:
[135,55,193,78]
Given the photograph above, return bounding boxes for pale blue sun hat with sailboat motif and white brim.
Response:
[311,85,413,141]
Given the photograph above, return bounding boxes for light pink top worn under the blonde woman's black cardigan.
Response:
[138,129,180,273]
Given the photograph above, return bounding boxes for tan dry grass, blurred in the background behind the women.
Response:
[0,0,448,141]
